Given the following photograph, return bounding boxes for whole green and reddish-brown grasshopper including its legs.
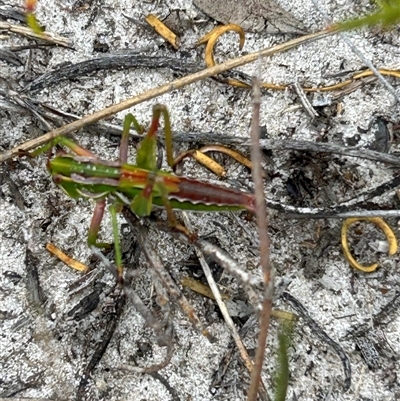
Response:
[37,104,255,283]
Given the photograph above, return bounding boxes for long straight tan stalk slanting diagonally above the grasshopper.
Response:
[0,29,338,163]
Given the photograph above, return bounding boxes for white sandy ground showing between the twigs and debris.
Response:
[0,0,400,401]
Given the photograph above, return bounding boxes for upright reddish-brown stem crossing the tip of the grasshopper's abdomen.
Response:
[247,78,274,401]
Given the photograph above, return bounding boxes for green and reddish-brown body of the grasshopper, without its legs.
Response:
[48,156,254,212]
